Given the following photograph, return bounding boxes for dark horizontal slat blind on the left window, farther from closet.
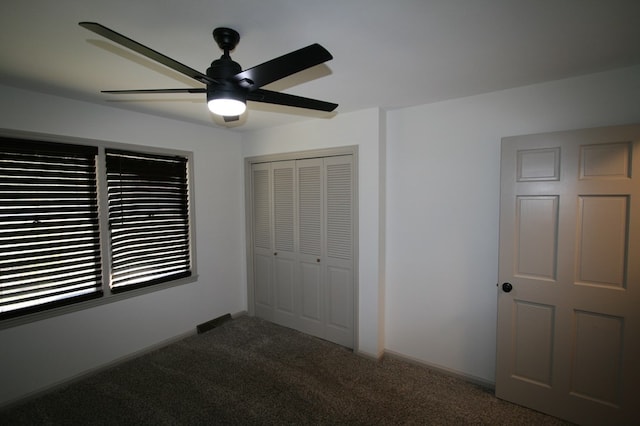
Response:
[0,138,102,318]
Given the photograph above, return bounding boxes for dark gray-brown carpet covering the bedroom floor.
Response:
[0,317,567,425]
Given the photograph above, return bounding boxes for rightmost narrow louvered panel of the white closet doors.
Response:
[323,155,355,347]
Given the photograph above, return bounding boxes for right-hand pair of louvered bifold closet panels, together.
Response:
[296,155,355,347]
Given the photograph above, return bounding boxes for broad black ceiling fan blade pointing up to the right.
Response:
[233,43,333,90]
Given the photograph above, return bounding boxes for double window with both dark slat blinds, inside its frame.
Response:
[0,137,191,319]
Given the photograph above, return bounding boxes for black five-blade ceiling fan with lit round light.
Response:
[79,22,338,122]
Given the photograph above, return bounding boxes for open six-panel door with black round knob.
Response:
[496,125,640,424]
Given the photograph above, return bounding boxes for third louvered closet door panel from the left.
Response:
[296,158,326,337]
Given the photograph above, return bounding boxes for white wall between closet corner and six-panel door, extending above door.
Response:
[385,67,640,383]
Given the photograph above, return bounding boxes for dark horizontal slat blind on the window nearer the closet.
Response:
[106,149,191,292]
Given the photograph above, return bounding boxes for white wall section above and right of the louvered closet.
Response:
[242,109,384,357]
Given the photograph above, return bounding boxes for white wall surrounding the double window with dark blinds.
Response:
[0,86,246,405]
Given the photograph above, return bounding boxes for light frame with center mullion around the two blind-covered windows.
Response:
[0,129,198,330]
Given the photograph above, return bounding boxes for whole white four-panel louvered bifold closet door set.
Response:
[248,155,356,348]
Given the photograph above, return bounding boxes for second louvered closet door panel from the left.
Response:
[271,161,299,328]
